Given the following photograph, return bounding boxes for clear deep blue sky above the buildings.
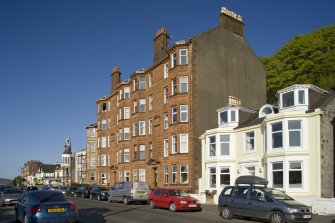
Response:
[0,0,335,179]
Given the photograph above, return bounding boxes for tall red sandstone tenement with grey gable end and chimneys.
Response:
[94,8,266,193]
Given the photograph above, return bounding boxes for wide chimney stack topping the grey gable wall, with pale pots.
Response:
[220,7,244,36]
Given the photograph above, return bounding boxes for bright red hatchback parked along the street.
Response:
[148,188,202,212]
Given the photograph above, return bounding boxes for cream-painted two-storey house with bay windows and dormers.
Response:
[199,84,335,213]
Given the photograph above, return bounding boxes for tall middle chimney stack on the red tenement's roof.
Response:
[154,28,169,64]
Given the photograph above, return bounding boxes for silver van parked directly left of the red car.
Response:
[108,181,151,204]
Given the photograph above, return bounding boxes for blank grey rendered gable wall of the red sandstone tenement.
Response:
[191,27,266,192]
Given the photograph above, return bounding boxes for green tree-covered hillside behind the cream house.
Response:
[261,25,335,103]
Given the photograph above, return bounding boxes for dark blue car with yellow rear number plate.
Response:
[15,190,79,222]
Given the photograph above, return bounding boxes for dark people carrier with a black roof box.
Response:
[218,176,313,223]
